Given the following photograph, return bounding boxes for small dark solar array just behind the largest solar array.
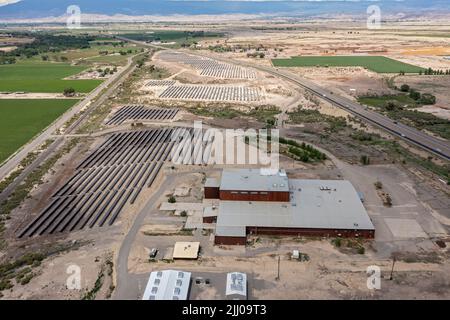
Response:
[106,105,178,125]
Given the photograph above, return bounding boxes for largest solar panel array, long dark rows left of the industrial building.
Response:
[18,128,188,237]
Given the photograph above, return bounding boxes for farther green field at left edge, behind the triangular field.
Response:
[0,61,102,93]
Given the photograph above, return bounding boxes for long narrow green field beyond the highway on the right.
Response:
[272,56,425,73]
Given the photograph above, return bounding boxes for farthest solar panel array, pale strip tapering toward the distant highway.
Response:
[159,51,256,80]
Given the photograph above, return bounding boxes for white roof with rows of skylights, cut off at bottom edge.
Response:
[142,270,191,300]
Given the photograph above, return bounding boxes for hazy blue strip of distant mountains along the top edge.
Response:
[0,0,450,20]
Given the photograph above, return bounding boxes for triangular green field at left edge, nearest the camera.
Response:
[0,99,78,163]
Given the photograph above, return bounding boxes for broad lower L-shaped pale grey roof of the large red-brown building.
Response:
[216,180,375,236]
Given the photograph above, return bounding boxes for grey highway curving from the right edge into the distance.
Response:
[120,37,450,160]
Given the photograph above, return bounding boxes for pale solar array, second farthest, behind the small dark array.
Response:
[159,85,261,102]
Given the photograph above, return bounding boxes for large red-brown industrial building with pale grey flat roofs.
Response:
[203,169,375,245]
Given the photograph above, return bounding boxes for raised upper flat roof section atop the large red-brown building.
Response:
[220,169,289,192]
